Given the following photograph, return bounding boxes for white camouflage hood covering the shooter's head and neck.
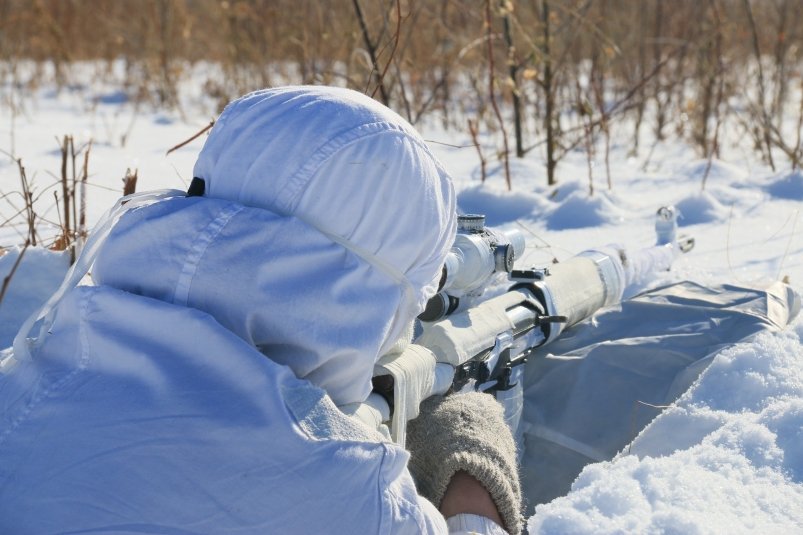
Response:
[93,87,456,404]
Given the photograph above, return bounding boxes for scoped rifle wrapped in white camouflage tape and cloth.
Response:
[341,206,694,446]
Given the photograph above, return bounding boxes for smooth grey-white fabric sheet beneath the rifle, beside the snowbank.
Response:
[521,282,800,506]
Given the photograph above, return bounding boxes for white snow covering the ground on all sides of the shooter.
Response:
[0,69,803,533]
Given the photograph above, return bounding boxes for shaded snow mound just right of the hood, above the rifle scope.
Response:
[457,185,548,227]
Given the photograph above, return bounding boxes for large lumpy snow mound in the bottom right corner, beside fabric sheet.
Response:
[528,317,803,534]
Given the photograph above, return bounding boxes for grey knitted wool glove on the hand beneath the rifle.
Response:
[407,392,522,535]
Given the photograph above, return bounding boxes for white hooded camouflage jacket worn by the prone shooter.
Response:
[0,87,462,533]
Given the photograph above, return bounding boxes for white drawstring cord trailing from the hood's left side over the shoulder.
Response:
[0,190,186,373]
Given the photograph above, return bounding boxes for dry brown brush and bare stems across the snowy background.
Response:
[0,0,803,193]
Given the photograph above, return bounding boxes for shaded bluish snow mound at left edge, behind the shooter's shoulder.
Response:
[0,247,70,348]
